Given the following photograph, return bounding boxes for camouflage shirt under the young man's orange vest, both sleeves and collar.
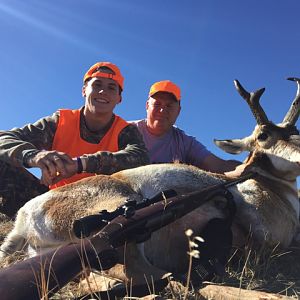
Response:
[0,109,149,174]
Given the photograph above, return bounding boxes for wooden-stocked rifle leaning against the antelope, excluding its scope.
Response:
[0,173,253,300]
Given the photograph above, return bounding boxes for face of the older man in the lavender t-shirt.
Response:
[146,92,180,136]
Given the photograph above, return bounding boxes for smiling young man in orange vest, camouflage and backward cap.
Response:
[0,62,149,213]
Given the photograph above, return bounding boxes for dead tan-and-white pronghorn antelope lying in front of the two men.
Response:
[1,78,300,282]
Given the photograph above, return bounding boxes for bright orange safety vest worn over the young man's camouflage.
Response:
[49,109,129,189]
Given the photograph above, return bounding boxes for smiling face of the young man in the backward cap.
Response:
[82,77,121,114]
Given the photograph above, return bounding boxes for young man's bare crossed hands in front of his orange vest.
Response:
[28,151,77,185]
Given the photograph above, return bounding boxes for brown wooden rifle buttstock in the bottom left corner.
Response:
[0,235,118,300]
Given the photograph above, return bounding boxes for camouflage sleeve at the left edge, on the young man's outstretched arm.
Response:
[0,112,59,167]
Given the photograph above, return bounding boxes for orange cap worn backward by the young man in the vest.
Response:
[83,62,124,90]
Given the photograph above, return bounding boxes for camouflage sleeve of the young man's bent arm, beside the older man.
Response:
[84,125,150,175]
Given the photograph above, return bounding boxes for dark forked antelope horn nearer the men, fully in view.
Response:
[234,80,269,125]
